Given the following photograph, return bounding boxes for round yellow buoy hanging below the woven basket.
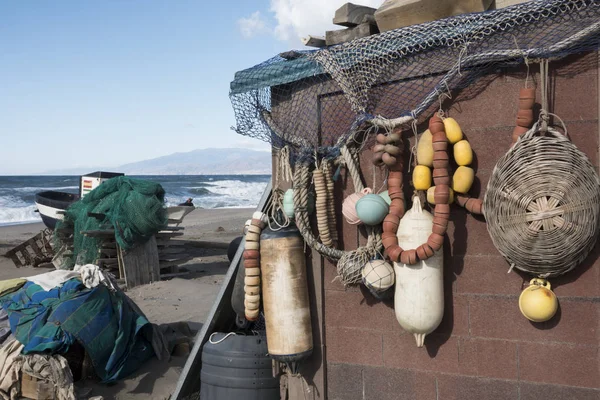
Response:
[519,278,558,322]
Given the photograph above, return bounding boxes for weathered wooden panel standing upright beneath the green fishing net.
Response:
[121,236,160,289]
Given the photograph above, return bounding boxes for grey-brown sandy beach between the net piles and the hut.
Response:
[0,208,254,399]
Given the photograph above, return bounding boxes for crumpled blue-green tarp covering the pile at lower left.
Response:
[0,279,154,382]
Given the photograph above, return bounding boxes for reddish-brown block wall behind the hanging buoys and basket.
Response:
[322,53,600,400]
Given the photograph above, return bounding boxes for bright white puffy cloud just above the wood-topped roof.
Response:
[268,0,384,44]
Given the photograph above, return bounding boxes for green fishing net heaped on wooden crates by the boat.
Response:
[55,176,168,268]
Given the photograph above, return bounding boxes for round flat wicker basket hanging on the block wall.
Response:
[484,124,600,278]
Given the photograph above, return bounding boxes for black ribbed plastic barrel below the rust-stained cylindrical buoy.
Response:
[200,333,280,400]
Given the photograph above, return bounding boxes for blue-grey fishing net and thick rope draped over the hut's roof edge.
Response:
[230,0,600,284]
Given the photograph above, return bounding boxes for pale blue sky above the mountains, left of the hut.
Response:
[0,0,382,175]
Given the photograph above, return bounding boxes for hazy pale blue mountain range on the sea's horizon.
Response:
[44,148,271,175]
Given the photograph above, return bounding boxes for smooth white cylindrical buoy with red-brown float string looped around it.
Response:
[394,197,444,347]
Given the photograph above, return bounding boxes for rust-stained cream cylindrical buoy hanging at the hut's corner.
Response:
[260,224,313,362]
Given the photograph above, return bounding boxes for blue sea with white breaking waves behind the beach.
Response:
[0,175,271,225]
